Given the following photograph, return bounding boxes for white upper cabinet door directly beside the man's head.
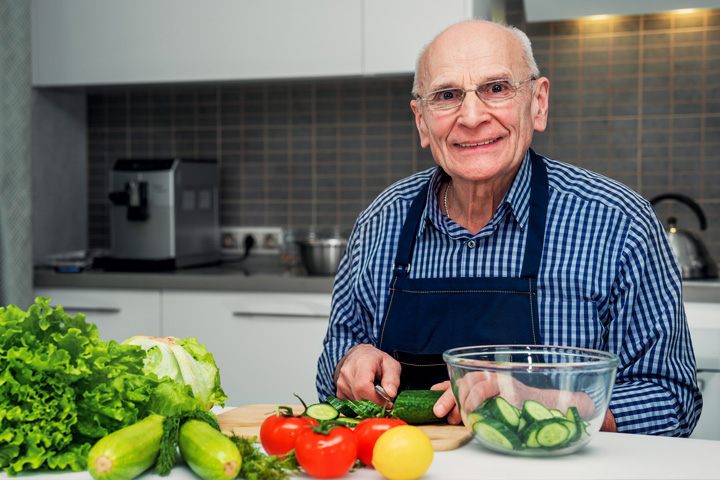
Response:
[363,0,473,75]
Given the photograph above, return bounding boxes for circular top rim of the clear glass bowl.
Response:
[443,345,620,371]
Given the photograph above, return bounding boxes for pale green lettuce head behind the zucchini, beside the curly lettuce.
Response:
[123,335,227,410]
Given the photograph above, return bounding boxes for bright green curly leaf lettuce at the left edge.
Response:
[0,297,218,476]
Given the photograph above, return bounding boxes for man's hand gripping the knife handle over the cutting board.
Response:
[335,343,401,405]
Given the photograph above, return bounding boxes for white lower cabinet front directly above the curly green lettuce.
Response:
[35,288,161,342]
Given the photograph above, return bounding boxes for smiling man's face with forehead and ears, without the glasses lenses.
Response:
[411,23,548,186]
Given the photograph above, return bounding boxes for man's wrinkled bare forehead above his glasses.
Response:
[419,25,527,93]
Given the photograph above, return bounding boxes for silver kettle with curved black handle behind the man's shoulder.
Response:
[650,193,718,280]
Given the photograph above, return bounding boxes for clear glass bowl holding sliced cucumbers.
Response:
[443,345,620,456]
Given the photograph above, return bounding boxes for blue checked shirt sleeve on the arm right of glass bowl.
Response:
[607,202,702,436]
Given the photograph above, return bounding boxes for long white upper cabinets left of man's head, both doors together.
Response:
[32,0,473,87]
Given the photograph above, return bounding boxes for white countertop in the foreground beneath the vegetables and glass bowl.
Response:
[0,432,720,480]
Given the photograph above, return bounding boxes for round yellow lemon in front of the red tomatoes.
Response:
[372,425,433,480]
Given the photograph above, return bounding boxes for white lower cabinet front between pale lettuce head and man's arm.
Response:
[162,291,330,406]
